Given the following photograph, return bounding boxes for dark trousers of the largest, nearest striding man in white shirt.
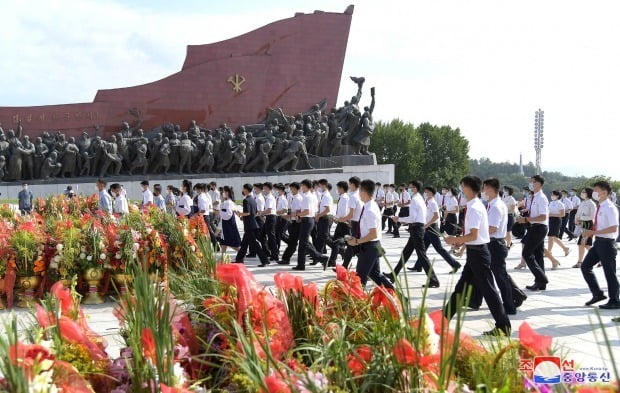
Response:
[443,244,510,329]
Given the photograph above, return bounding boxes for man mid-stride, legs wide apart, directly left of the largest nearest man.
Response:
[386,180,439,288]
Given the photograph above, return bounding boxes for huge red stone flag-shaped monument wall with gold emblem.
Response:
[0,5,353,136]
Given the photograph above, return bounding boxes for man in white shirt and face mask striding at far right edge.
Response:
[581,181,620,310]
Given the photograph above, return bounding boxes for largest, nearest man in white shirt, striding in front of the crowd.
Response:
[443,176,511,336]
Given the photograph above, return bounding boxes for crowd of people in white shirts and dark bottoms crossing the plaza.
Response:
[89,175,620,335]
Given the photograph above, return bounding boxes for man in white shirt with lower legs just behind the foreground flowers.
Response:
[348,179,394,289]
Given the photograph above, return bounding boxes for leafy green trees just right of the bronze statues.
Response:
[370,119,469,186]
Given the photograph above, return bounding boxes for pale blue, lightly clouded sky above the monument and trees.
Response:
[0,0,620,178]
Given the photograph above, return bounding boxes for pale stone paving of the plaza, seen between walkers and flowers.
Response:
[0,222,620,369]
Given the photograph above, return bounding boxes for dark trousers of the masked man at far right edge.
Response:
[581,238,620,303]
